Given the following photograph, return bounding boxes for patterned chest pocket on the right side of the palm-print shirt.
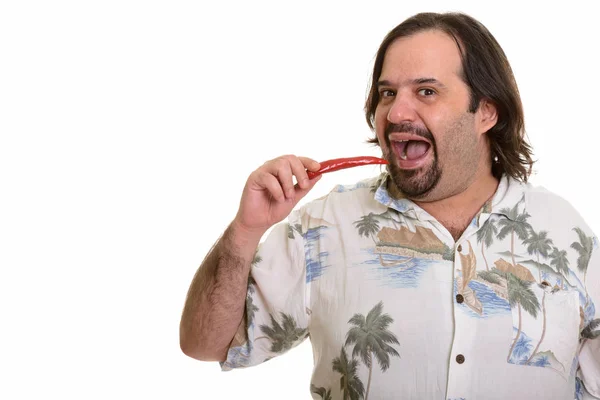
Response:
[507,279,580,379]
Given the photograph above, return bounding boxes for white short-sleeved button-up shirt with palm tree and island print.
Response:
[221,174,600,400]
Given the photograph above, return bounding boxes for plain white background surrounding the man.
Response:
[0,0,600,399]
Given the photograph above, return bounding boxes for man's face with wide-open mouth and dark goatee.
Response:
[375,30,489,201]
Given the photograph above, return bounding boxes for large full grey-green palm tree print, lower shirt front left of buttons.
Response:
[345,302,400,400]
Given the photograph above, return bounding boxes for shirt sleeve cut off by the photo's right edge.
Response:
[574,236,600,399]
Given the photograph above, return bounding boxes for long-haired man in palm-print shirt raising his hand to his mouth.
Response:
[180,13,600,399]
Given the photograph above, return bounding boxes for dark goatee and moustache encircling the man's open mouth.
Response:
[384,122,442,199]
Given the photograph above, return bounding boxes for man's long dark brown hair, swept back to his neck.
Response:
[365,13,534,182]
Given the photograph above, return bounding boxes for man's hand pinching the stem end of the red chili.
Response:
[233,155,321,236]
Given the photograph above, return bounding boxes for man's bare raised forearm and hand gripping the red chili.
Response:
[179,156,320,361]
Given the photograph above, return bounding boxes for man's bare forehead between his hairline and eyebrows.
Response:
[380,30,462,80]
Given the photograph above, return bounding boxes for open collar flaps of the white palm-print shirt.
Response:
[374,172,527,222]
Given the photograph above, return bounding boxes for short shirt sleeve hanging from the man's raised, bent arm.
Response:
[221,211,309,371]
